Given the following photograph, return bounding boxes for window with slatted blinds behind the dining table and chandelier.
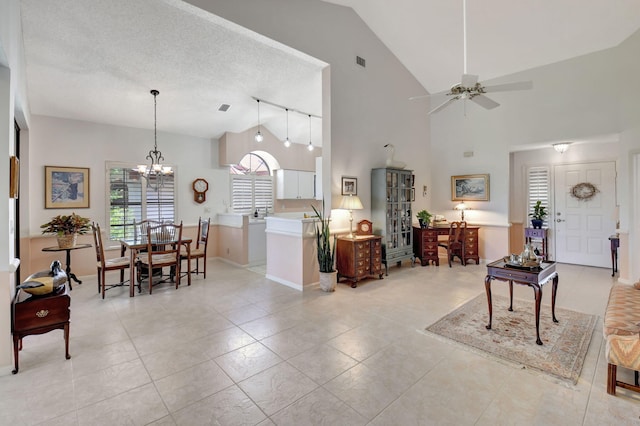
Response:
[107,164,175,240]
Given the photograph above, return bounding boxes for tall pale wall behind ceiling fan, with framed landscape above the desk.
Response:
[431,28,640,262]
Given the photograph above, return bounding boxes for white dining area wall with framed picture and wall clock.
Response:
[29,115,229,231]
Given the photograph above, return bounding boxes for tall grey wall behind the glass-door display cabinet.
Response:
[188,0,431,228]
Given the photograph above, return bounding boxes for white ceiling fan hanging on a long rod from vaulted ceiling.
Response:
[409,0,533,114]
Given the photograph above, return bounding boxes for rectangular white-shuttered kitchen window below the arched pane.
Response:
[231,175,273,213]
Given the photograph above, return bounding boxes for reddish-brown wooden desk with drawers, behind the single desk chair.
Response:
[413,226,480,266]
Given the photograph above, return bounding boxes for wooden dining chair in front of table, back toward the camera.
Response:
[136,222,182,294]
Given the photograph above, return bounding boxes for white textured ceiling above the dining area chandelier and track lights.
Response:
[21,0,326,145]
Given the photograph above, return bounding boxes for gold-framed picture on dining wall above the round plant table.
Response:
[44,166,89,209]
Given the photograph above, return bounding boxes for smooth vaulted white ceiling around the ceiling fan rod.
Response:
[324,0,640,93]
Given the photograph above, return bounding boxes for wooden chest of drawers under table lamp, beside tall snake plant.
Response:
[336,235,382,288]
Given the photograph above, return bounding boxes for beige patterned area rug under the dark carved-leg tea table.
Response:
[426,293,596,384]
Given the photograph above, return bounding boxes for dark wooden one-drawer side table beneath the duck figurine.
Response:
[11,284,71,374]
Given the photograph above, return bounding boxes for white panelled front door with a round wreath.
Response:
[549,161,616,268]
